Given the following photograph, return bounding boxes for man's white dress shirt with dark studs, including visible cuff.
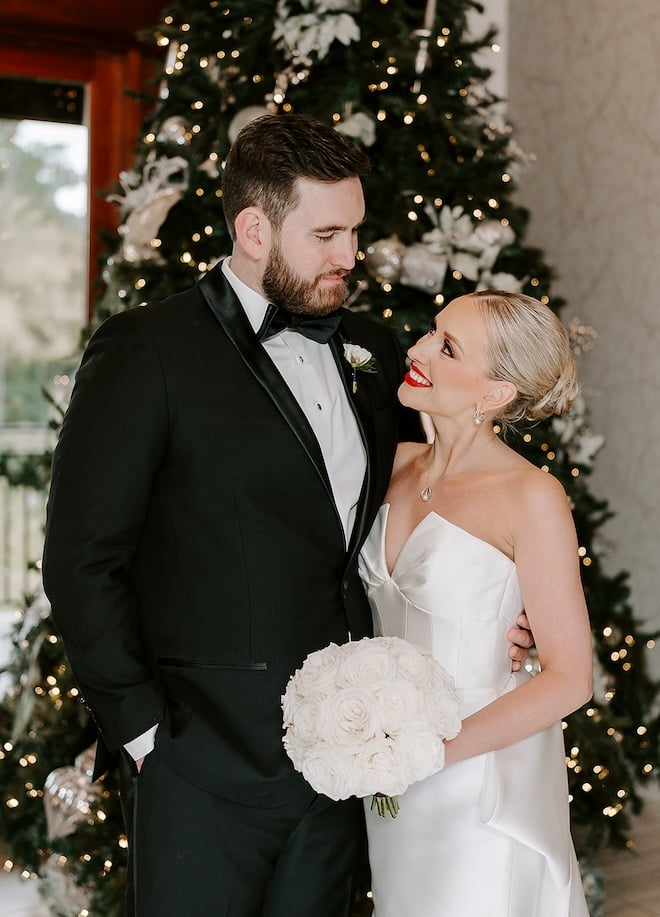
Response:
[124,258,367,760]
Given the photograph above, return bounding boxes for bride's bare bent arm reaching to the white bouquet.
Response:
[445,473,592,764]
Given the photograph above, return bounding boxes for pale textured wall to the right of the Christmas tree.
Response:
[506,0,660,675]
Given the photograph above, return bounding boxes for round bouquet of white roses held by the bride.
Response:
[282,637,461,817]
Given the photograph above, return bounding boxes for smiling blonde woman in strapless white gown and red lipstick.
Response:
[361,291,592,917]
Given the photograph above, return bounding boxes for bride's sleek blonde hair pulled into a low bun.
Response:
[471,290,580,428]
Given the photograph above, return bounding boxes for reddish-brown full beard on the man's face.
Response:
[261,242,348,315]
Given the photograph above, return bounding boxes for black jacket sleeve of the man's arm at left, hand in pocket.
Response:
[43,310,168,750]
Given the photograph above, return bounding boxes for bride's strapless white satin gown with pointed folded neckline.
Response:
[360,505,589,917]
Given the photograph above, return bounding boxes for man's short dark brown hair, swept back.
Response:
[222,114,369,239]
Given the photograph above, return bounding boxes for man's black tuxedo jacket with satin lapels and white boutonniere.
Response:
[43,266,416,805]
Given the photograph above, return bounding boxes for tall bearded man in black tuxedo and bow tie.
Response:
[43,115,526,917]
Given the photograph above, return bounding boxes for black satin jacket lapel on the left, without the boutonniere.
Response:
[199,265,334,505]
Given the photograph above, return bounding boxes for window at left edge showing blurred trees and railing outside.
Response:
[0,77,88,604]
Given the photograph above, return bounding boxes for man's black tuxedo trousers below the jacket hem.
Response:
[120,749,366,917]
